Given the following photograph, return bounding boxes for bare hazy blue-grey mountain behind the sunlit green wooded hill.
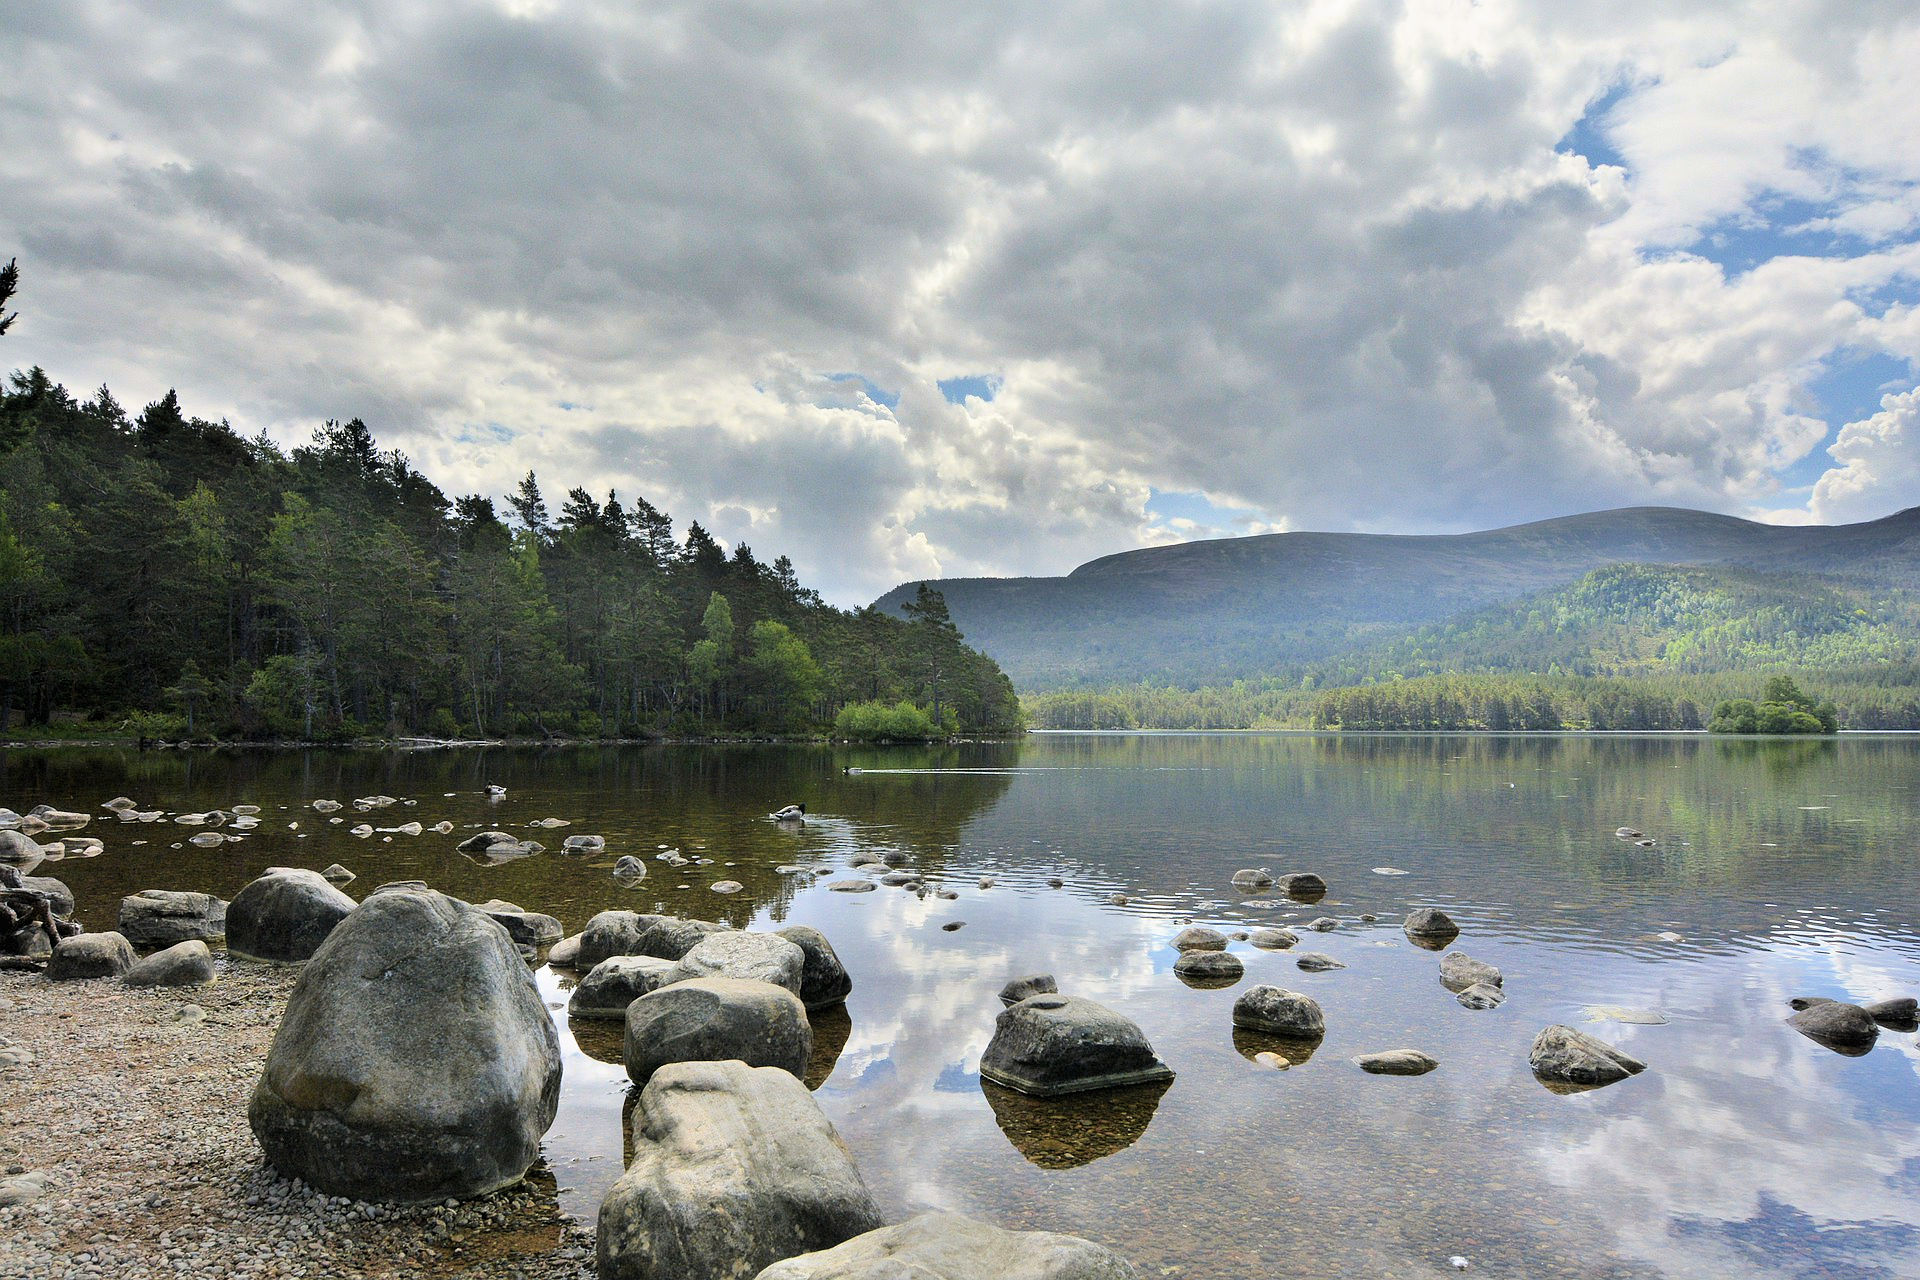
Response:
[877,507,1920,691]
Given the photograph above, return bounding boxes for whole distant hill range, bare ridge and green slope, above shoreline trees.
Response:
[877,507,1920,691]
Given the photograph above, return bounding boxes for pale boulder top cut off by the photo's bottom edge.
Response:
[755,1213,1140,1280]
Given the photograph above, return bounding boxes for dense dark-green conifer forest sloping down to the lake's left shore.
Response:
[0,368,1020,739]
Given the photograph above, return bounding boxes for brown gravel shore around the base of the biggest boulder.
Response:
[0,963,593,1280]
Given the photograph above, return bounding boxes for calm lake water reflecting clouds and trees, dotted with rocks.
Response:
[0,735,1920,1280]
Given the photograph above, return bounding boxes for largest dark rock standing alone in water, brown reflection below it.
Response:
[979,996,1173,1098]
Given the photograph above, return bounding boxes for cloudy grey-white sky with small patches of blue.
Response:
[0,0,1920,604]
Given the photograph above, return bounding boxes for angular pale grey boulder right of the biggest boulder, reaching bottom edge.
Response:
[597,1061,883,1280]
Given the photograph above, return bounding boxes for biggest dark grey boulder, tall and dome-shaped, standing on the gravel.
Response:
[247,887,561,1201]
